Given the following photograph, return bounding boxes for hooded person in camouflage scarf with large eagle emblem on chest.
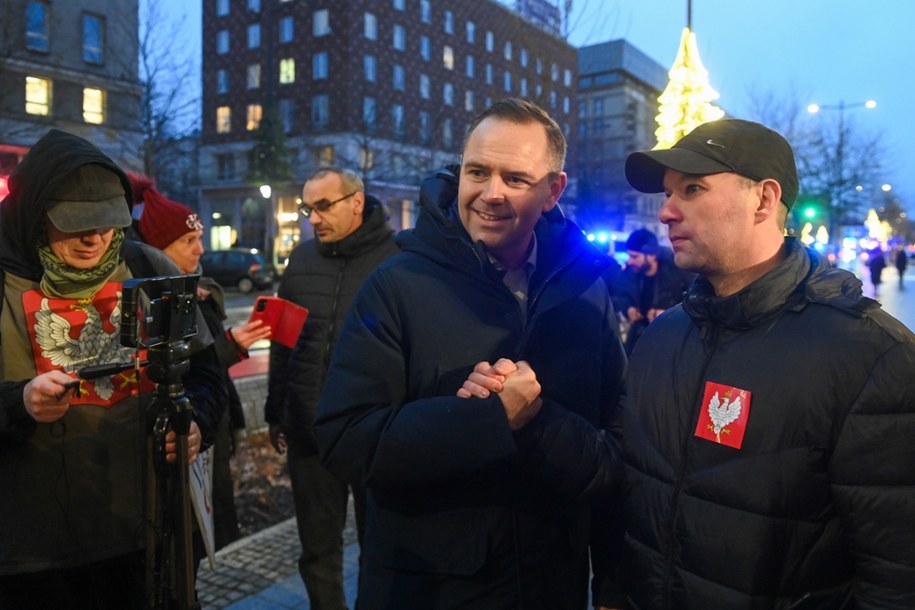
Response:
[0,130,226,609]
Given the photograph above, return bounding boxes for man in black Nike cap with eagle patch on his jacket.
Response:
[465,120,915,609]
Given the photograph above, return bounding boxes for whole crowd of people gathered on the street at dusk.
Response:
[0,98,915,610]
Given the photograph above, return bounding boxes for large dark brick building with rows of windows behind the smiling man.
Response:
[199,0,577,263]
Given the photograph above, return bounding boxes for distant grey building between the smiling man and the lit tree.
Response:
[569,40,667,241]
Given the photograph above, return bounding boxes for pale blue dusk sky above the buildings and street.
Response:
[159,0,915,209]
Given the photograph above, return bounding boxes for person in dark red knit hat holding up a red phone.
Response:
[130,175,271,549]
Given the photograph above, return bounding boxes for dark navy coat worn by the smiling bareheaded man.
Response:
[317,170,625,610]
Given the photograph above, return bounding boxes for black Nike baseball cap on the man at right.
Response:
[626,119,798,210]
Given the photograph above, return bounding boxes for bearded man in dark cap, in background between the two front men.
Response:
[614,229,694,354]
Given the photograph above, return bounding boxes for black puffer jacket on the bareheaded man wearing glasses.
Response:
[265,195,399,455]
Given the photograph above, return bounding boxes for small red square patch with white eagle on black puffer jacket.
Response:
[696,381,752,449]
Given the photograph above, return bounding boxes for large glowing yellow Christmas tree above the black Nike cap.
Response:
[655,27,724,148]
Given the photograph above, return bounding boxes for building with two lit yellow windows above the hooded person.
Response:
[0,0,142,186]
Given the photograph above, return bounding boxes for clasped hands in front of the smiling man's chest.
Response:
[457,358,543,430]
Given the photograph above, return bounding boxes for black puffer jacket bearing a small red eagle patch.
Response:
[622,239,915,610]
